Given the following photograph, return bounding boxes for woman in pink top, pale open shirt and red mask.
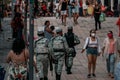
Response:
[103,31,119,78]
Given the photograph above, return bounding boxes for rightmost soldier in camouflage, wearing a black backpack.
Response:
[64,26,80,74]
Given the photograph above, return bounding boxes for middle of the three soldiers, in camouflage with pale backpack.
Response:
[49,28,69,80]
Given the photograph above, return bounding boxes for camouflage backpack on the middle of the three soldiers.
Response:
[52,36,64,52]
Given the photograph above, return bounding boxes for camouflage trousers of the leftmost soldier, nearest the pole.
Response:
[36,55,49,78]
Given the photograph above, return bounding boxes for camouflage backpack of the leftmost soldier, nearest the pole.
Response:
[35,38,48,53]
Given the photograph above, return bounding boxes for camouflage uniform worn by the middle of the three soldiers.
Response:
[49,28,69,80]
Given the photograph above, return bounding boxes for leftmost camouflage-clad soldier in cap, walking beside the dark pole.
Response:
[34,30,49,80]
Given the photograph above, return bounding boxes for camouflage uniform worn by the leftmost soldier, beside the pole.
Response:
[34,30,49,80]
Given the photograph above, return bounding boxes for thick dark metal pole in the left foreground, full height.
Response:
[29,0,34,80]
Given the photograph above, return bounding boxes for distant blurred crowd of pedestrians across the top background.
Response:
[0,0,120,31]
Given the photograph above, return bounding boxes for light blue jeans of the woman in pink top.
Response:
[106,54,115,74]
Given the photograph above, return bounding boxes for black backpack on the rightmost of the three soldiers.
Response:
[65,33,74,47]
